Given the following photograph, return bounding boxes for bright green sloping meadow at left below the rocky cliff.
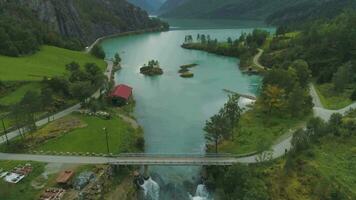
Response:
[0,46,106,81]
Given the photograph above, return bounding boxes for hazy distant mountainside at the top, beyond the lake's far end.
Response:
[160,0,356,23]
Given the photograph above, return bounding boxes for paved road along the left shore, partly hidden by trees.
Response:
[0,61,113,145]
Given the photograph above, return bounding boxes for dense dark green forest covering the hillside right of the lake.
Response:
[262,10,356,100]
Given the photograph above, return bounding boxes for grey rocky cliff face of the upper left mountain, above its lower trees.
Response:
[0,0,165,44]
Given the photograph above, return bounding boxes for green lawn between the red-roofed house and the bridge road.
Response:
[36,115,138,153]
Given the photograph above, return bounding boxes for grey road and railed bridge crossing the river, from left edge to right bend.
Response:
[0,134,291,166]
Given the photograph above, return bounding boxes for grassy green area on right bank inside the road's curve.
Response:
[219,110,309,154]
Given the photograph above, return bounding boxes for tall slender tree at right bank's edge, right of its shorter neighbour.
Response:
[223,95,242,137]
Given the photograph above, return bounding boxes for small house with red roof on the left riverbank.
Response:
[110,84,132,106]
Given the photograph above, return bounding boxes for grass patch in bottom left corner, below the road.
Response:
[0,161,44,200]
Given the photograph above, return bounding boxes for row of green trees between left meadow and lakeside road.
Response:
[2,62,108,144]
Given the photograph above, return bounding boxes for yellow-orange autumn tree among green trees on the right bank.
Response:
[262,85,285,113]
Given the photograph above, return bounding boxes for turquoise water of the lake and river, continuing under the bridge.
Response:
[102,20,274,200]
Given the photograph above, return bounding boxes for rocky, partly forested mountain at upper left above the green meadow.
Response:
[0,0,167,55]
